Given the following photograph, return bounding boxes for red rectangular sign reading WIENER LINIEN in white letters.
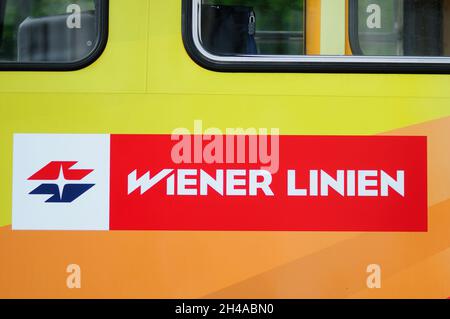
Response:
[110,135,427,231]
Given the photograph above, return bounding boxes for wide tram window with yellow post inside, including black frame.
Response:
[186,0,450,73]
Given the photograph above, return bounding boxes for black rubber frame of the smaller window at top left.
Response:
[0,0,109,71]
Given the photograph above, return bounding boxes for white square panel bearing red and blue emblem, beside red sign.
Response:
[12,134,110,230]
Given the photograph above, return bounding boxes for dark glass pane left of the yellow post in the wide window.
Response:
[200,0,304,55]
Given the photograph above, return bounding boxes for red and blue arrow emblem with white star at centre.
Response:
[28,161,95,203]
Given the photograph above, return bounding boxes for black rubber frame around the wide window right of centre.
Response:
[181,0,450,74]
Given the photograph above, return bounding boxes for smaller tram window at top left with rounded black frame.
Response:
[0,0,107,69]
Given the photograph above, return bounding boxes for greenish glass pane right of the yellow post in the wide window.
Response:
[351,0,450,56]
